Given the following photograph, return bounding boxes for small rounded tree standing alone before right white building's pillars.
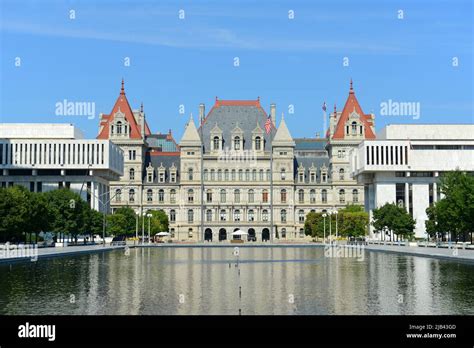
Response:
[372,203,416,239]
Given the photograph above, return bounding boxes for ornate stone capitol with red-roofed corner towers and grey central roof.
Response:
[97,81,375,241]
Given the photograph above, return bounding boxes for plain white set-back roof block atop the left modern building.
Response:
[0,123,84,139]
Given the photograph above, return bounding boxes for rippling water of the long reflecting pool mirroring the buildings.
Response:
[0,247,474,315]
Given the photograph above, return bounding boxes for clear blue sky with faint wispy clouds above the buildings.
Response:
[0,0,474,140]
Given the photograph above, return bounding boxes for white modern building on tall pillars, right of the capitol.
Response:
[351,124,474,238]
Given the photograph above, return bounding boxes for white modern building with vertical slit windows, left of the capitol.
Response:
[0,123,123,211]
